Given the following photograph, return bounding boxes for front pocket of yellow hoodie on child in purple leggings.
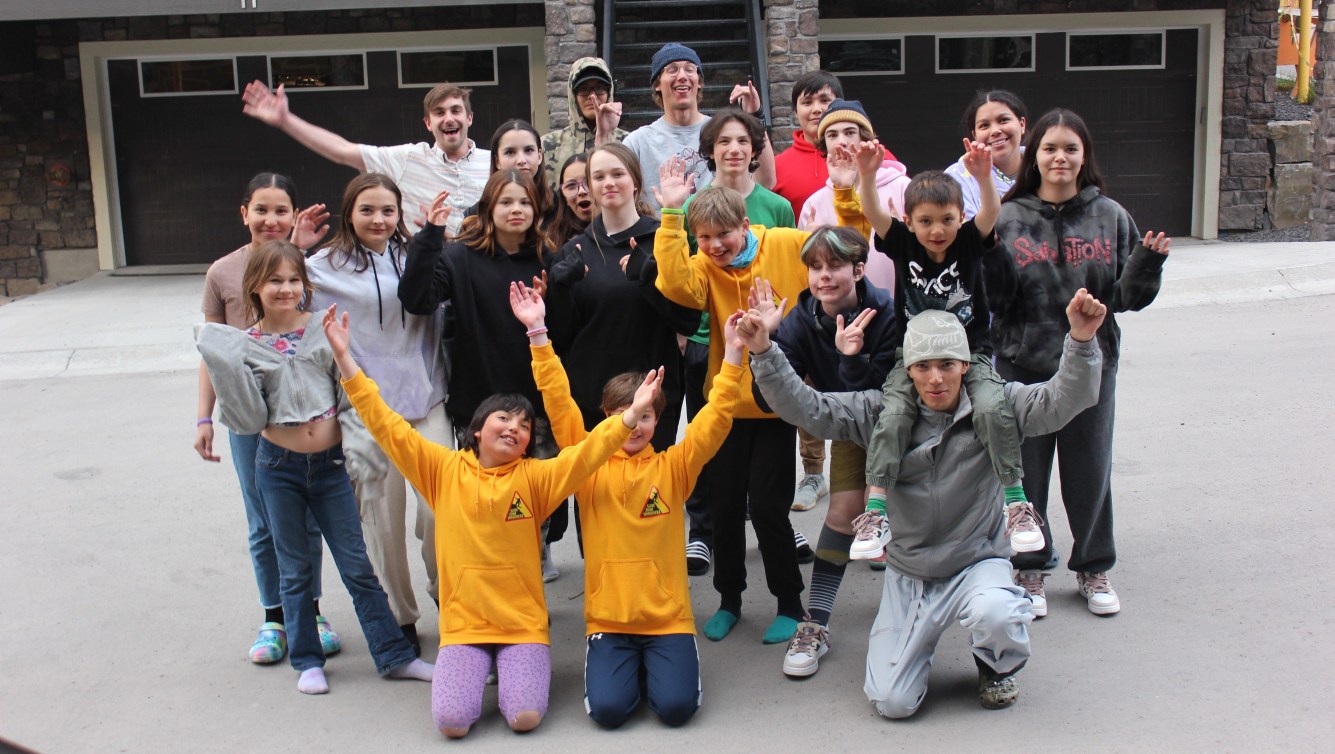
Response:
[442,566,546,633]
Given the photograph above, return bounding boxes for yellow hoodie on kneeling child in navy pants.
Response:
[533,346,742,635]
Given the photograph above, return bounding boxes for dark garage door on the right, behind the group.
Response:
[821,29,1197,235]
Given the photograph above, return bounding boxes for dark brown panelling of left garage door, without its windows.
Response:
[108,47,533,264]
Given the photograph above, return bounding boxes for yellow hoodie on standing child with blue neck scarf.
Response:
[654,212,810,419]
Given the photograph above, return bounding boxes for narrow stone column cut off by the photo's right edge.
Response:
[1311,3,1335,240]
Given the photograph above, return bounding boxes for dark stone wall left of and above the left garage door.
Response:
[0,0,544,296]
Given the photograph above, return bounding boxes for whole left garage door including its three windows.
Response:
[107,45,533,264]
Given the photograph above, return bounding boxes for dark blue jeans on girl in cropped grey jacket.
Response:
[255,438,417,675]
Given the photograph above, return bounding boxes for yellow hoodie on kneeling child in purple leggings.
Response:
[343,372,630,646]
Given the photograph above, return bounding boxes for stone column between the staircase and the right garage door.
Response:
[765,0,821,152]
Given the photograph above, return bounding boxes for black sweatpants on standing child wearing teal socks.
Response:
[702,419,802,613]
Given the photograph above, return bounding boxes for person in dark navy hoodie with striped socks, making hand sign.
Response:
[752,226,902,678]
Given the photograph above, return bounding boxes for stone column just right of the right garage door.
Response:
[1219,0,1279,230]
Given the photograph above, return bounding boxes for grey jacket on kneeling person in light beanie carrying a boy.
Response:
[752,335,1101,581]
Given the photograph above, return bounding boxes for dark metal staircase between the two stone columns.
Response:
[602,0,769,131]
